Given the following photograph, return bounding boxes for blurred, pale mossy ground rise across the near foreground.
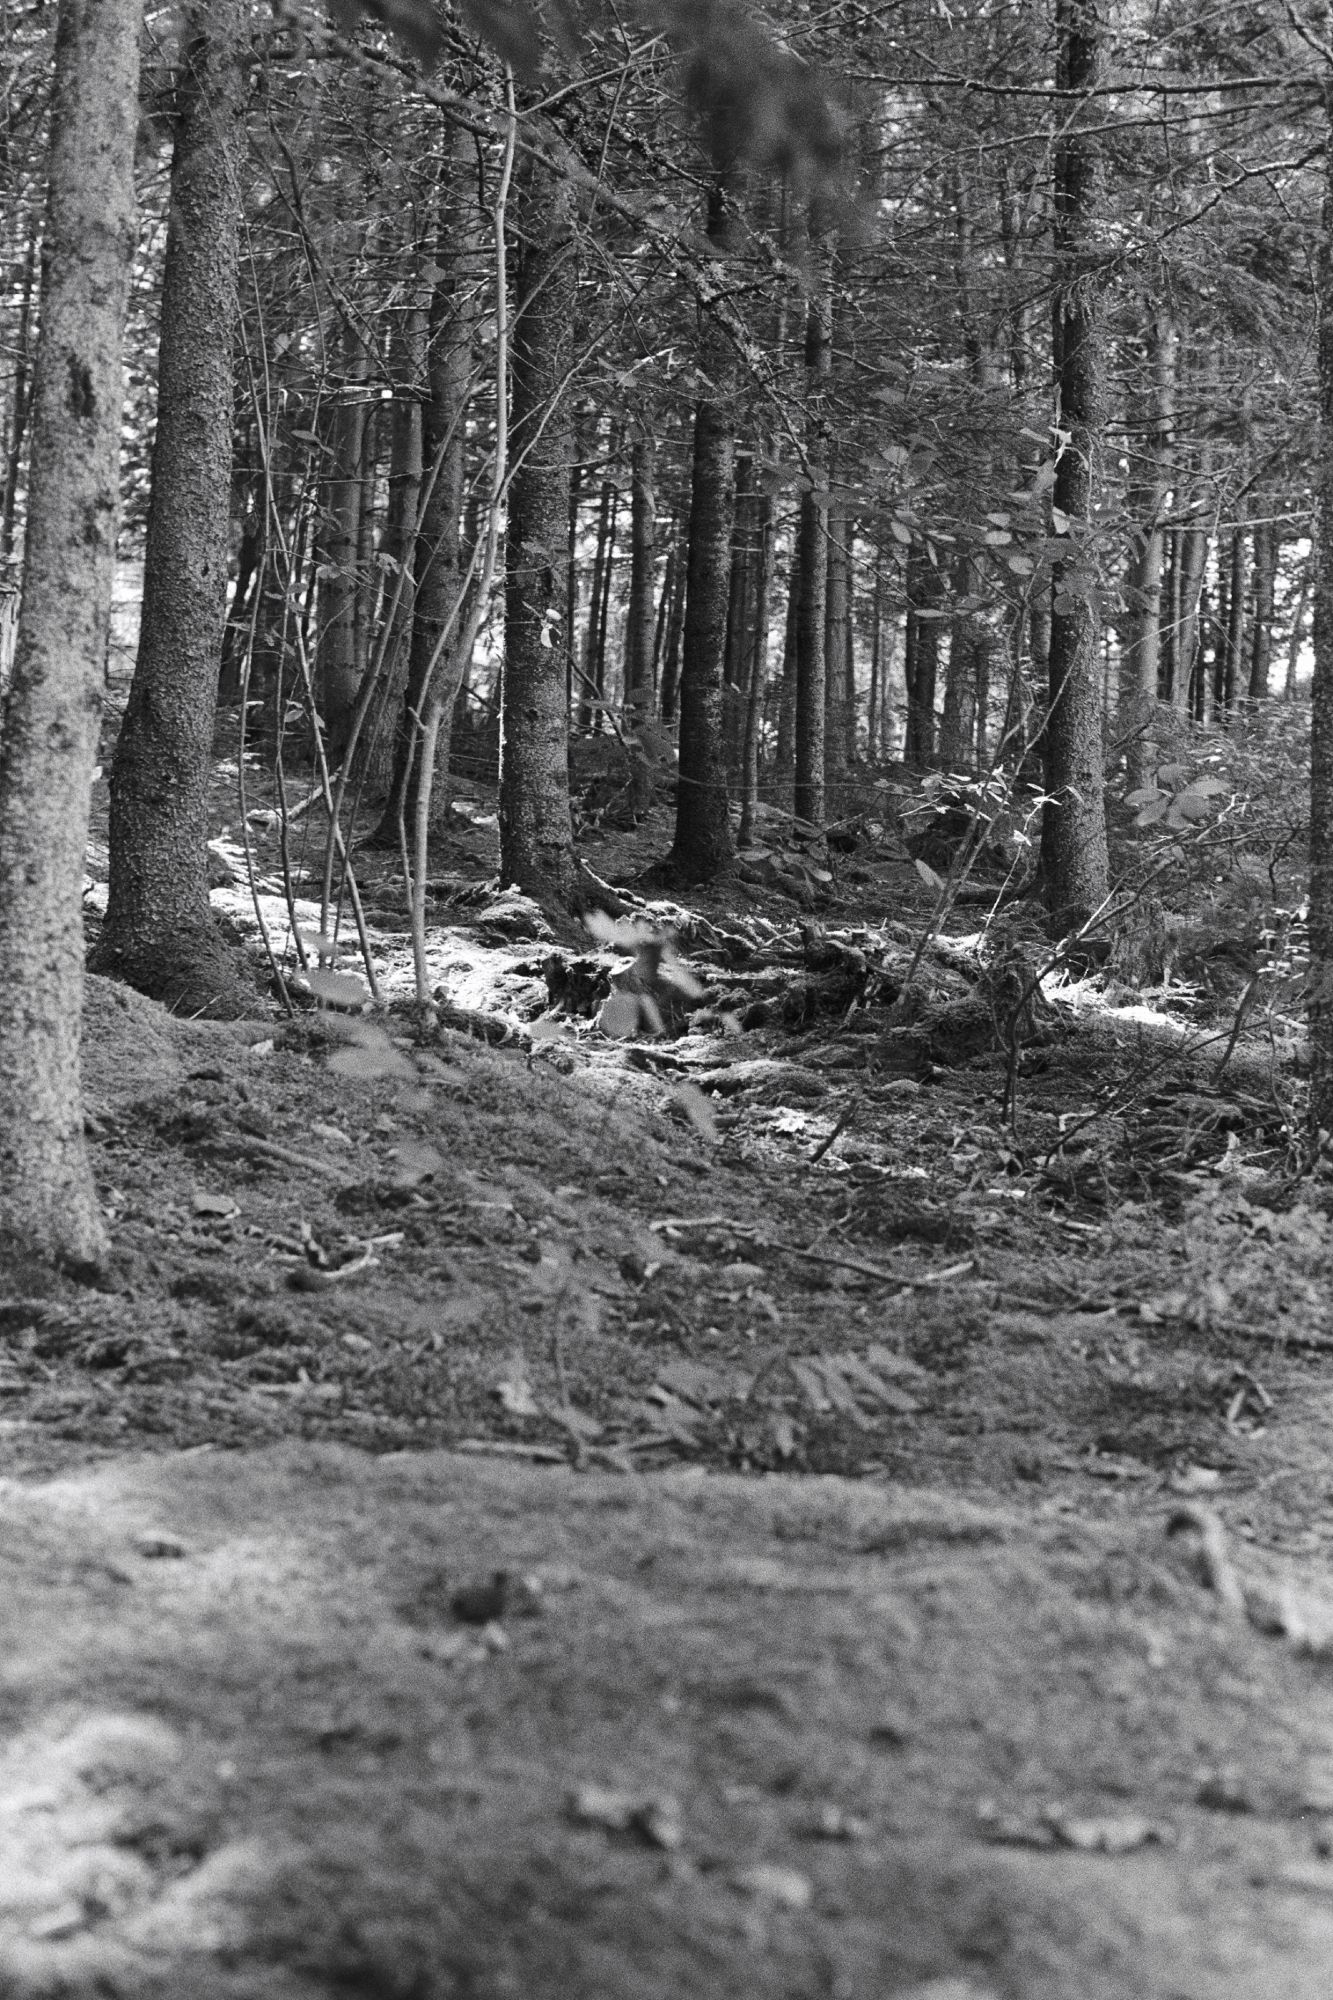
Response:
[0,1446,1333,2000]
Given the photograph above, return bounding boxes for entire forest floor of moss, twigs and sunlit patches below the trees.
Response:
[0,744,1333,2000]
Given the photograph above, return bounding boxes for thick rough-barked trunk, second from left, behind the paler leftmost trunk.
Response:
[92,0,258,1016]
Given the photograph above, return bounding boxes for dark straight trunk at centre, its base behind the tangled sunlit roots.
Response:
[671,202,737,882]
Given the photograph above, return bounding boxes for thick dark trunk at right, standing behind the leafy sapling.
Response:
[1041,0,1109,936]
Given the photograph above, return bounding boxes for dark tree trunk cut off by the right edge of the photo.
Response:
[1304,66,1333,1146]
